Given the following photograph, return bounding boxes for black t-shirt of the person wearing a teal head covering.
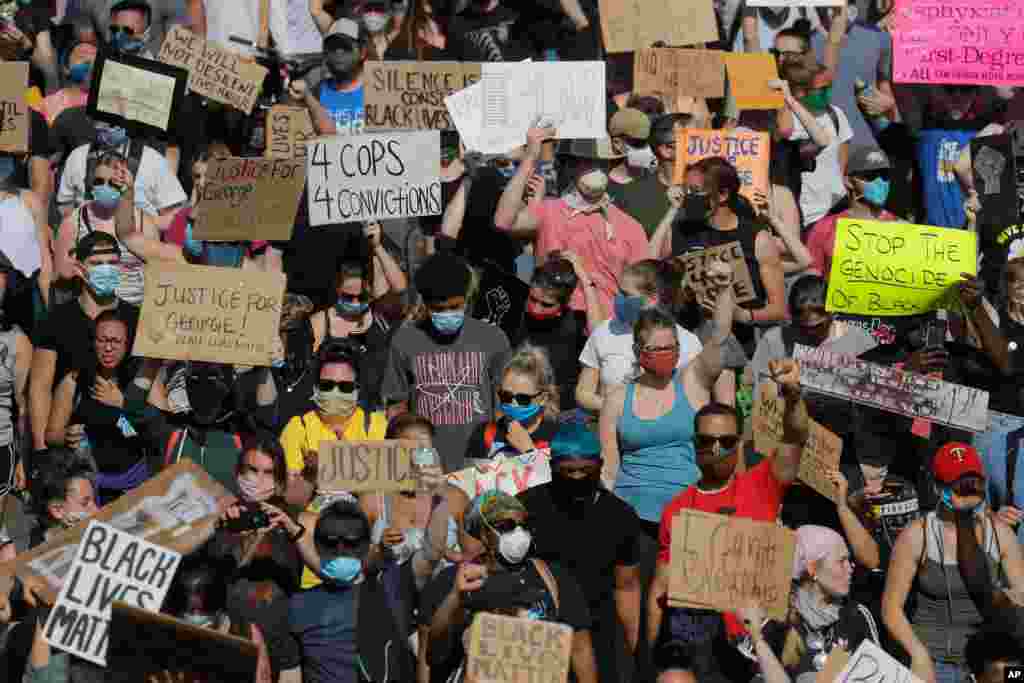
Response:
[518,483,640,610]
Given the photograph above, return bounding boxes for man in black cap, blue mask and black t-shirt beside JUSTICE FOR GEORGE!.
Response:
[29,230,138,450]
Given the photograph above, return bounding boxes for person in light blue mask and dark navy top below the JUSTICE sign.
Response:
[289,500,416,683]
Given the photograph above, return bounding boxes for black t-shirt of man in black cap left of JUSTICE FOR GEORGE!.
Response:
[35,299,138,386]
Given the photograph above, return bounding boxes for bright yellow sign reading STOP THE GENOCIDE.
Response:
[826,218,978,315]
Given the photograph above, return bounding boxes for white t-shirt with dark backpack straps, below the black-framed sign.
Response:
[57,144,188,216]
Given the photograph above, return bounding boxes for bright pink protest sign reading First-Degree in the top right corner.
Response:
[892,0,1024,86]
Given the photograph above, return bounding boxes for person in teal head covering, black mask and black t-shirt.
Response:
[518,423,641,681]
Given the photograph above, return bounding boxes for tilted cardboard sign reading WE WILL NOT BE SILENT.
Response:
[160,26,267,114]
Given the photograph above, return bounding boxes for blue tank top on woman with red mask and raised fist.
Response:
[615,372,700,522]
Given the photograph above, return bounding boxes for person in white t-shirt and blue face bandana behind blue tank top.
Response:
[575,260,702,413]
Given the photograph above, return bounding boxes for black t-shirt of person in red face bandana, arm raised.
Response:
[511,310,587,412]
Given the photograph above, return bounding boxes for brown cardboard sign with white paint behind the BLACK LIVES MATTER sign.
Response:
[0,459,228,603]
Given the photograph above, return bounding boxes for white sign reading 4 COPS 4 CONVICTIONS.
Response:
[306,130,444,225]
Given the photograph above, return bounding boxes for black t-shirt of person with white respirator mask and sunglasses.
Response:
[420,560,591,681]
